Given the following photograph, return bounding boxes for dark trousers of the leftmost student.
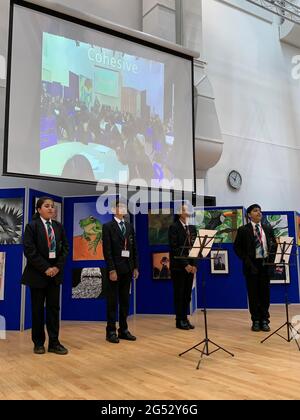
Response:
[30,282,60,347]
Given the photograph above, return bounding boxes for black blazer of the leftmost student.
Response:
[22,217,69,288]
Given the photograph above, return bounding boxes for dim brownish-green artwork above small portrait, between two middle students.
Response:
[148,209,174,245]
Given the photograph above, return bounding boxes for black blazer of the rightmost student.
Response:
[234,223,277,275]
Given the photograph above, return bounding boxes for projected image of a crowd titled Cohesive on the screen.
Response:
[40,32,175,185]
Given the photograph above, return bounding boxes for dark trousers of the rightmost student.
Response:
[246,260,270,322]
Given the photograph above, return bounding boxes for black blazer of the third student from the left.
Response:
[169,220,197,270]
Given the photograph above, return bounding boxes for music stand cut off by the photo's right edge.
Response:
[261,241,300,351]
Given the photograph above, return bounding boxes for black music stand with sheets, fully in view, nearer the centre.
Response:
[177,231,234,369]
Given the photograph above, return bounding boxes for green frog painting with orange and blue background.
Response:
[73,201,112,261]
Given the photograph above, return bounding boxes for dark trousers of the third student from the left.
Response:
[171,270,194,321]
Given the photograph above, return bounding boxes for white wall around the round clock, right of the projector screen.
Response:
[202,0,300,210]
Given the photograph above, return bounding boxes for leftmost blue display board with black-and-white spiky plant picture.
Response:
[0,188,25,330]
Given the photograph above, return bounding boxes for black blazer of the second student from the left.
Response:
[102,219,139,274]
